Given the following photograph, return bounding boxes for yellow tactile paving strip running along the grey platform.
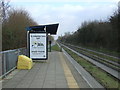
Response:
[59,53,79,88]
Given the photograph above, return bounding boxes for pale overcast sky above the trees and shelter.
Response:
[10,0,119,38]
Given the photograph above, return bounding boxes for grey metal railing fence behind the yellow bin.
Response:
[0,48,27,78]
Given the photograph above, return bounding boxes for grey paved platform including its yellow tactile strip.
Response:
[2,52,85,88]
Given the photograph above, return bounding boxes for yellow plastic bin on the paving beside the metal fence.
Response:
[17,55,33,69]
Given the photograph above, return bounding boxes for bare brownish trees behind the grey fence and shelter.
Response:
[0,0,54,51]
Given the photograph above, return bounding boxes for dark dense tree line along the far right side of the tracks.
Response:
[58,8,120,52]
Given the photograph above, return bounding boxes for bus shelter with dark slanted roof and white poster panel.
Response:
[26,24,59,60]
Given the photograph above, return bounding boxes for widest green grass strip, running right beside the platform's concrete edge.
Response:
[64,48,120,89]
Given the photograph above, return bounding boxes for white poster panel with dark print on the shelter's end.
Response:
[30,33,47,59]
